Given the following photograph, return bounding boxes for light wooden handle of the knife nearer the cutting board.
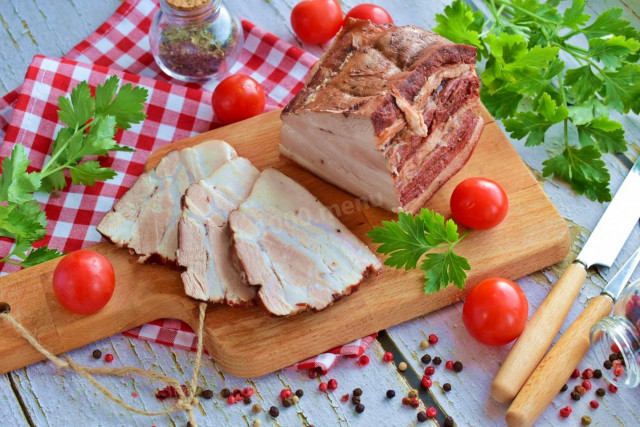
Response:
[490,263,587,403]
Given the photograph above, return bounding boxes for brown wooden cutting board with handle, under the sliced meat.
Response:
[0,107,569,377]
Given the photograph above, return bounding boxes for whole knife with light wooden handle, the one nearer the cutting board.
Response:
[491,158,640,403]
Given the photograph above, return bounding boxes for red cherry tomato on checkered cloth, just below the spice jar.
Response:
[212,74,265,125]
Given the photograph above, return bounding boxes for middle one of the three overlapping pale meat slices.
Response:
[178,157,260,305]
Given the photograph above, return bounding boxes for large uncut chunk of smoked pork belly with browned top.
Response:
[280,19,483,212]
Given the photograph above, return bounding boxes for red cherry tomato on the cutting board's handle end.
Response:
[53,249,116,314]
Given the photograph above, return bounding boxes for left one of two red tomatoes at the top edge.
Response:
[291,0,342,44]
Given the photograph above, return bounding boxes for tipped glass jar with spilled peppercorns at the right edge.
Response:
[591,280,640,387]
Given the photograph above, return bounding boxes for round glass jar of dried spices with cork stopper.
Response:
[149,0,243,82]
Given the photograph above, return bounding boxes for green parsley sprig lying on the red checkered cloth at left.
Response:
[0,76,147,267]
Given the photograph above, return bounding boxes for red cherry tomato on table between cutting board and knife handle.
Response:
[462,278,529,346]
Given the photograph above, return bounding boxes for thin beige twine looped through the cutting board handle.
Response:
[0,302,207,427]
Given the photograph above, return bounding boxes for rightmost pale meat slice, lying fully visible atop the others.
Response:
[229,169,382,316]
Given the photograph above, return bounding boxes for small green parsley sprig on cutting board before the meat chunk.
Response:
[368,208,471,294]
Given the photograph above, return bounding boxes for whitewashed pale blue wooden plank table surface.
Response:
[0,0,640,426]
